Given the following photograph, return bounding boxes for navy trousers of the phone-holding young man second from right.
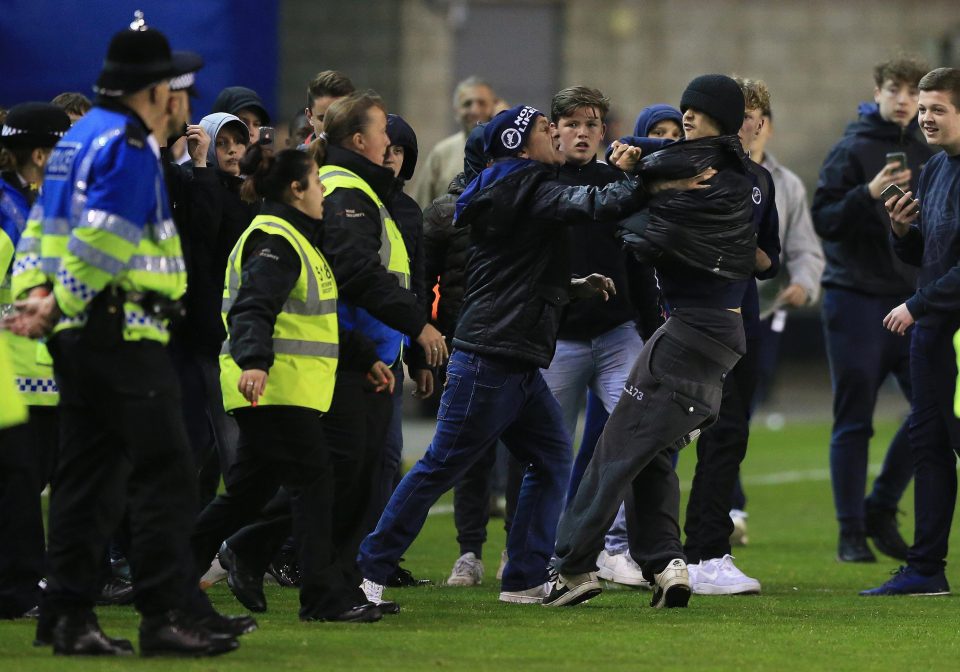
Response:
[823,288,913,534]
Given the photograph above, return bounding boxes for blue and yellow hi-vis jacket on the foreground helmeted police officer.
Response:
[13,105,186,343]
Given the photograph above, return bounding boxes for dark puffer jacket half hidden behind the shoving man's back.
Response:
[423,173,470,338]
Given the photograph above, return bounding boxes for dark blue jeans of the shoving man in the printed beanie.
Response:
[357,350,571,590]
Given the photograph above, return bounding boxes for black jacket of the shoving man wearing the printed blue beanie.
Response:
[453,161,646,367]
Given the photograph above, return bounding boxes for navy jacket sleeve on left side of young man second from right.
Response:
[811,144,875,240]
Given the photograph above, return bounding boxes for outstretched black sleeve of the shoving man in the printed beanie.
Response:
[529,178,648,224]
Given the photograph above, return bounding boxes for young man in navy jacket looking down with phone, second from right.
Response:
[813,59,932,562]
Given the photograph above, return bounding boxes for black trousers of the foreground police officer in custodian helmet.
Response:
[43,329,196,616]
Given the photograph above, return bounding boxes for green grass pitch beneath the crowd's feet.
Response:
[0,422,960,672]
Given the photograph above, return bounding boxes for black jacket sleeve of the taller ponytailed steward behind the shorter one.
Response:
[321,188,427,338]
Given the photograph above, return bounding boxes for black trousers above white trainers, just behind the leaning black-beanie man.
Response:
[683,340,759,563]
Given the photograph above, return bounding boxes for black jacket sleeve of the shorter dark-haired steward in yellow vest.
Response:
[227,232,302,371]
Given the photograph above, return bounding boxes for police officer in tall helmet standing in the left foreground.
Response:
[8,14,238,656]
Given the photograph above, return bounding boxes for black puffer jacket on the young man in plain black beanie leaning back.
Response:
[621,135,757,280]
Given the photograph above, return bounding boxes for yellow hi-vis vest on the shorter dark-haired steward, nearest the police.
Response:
[220,215,340,411]
